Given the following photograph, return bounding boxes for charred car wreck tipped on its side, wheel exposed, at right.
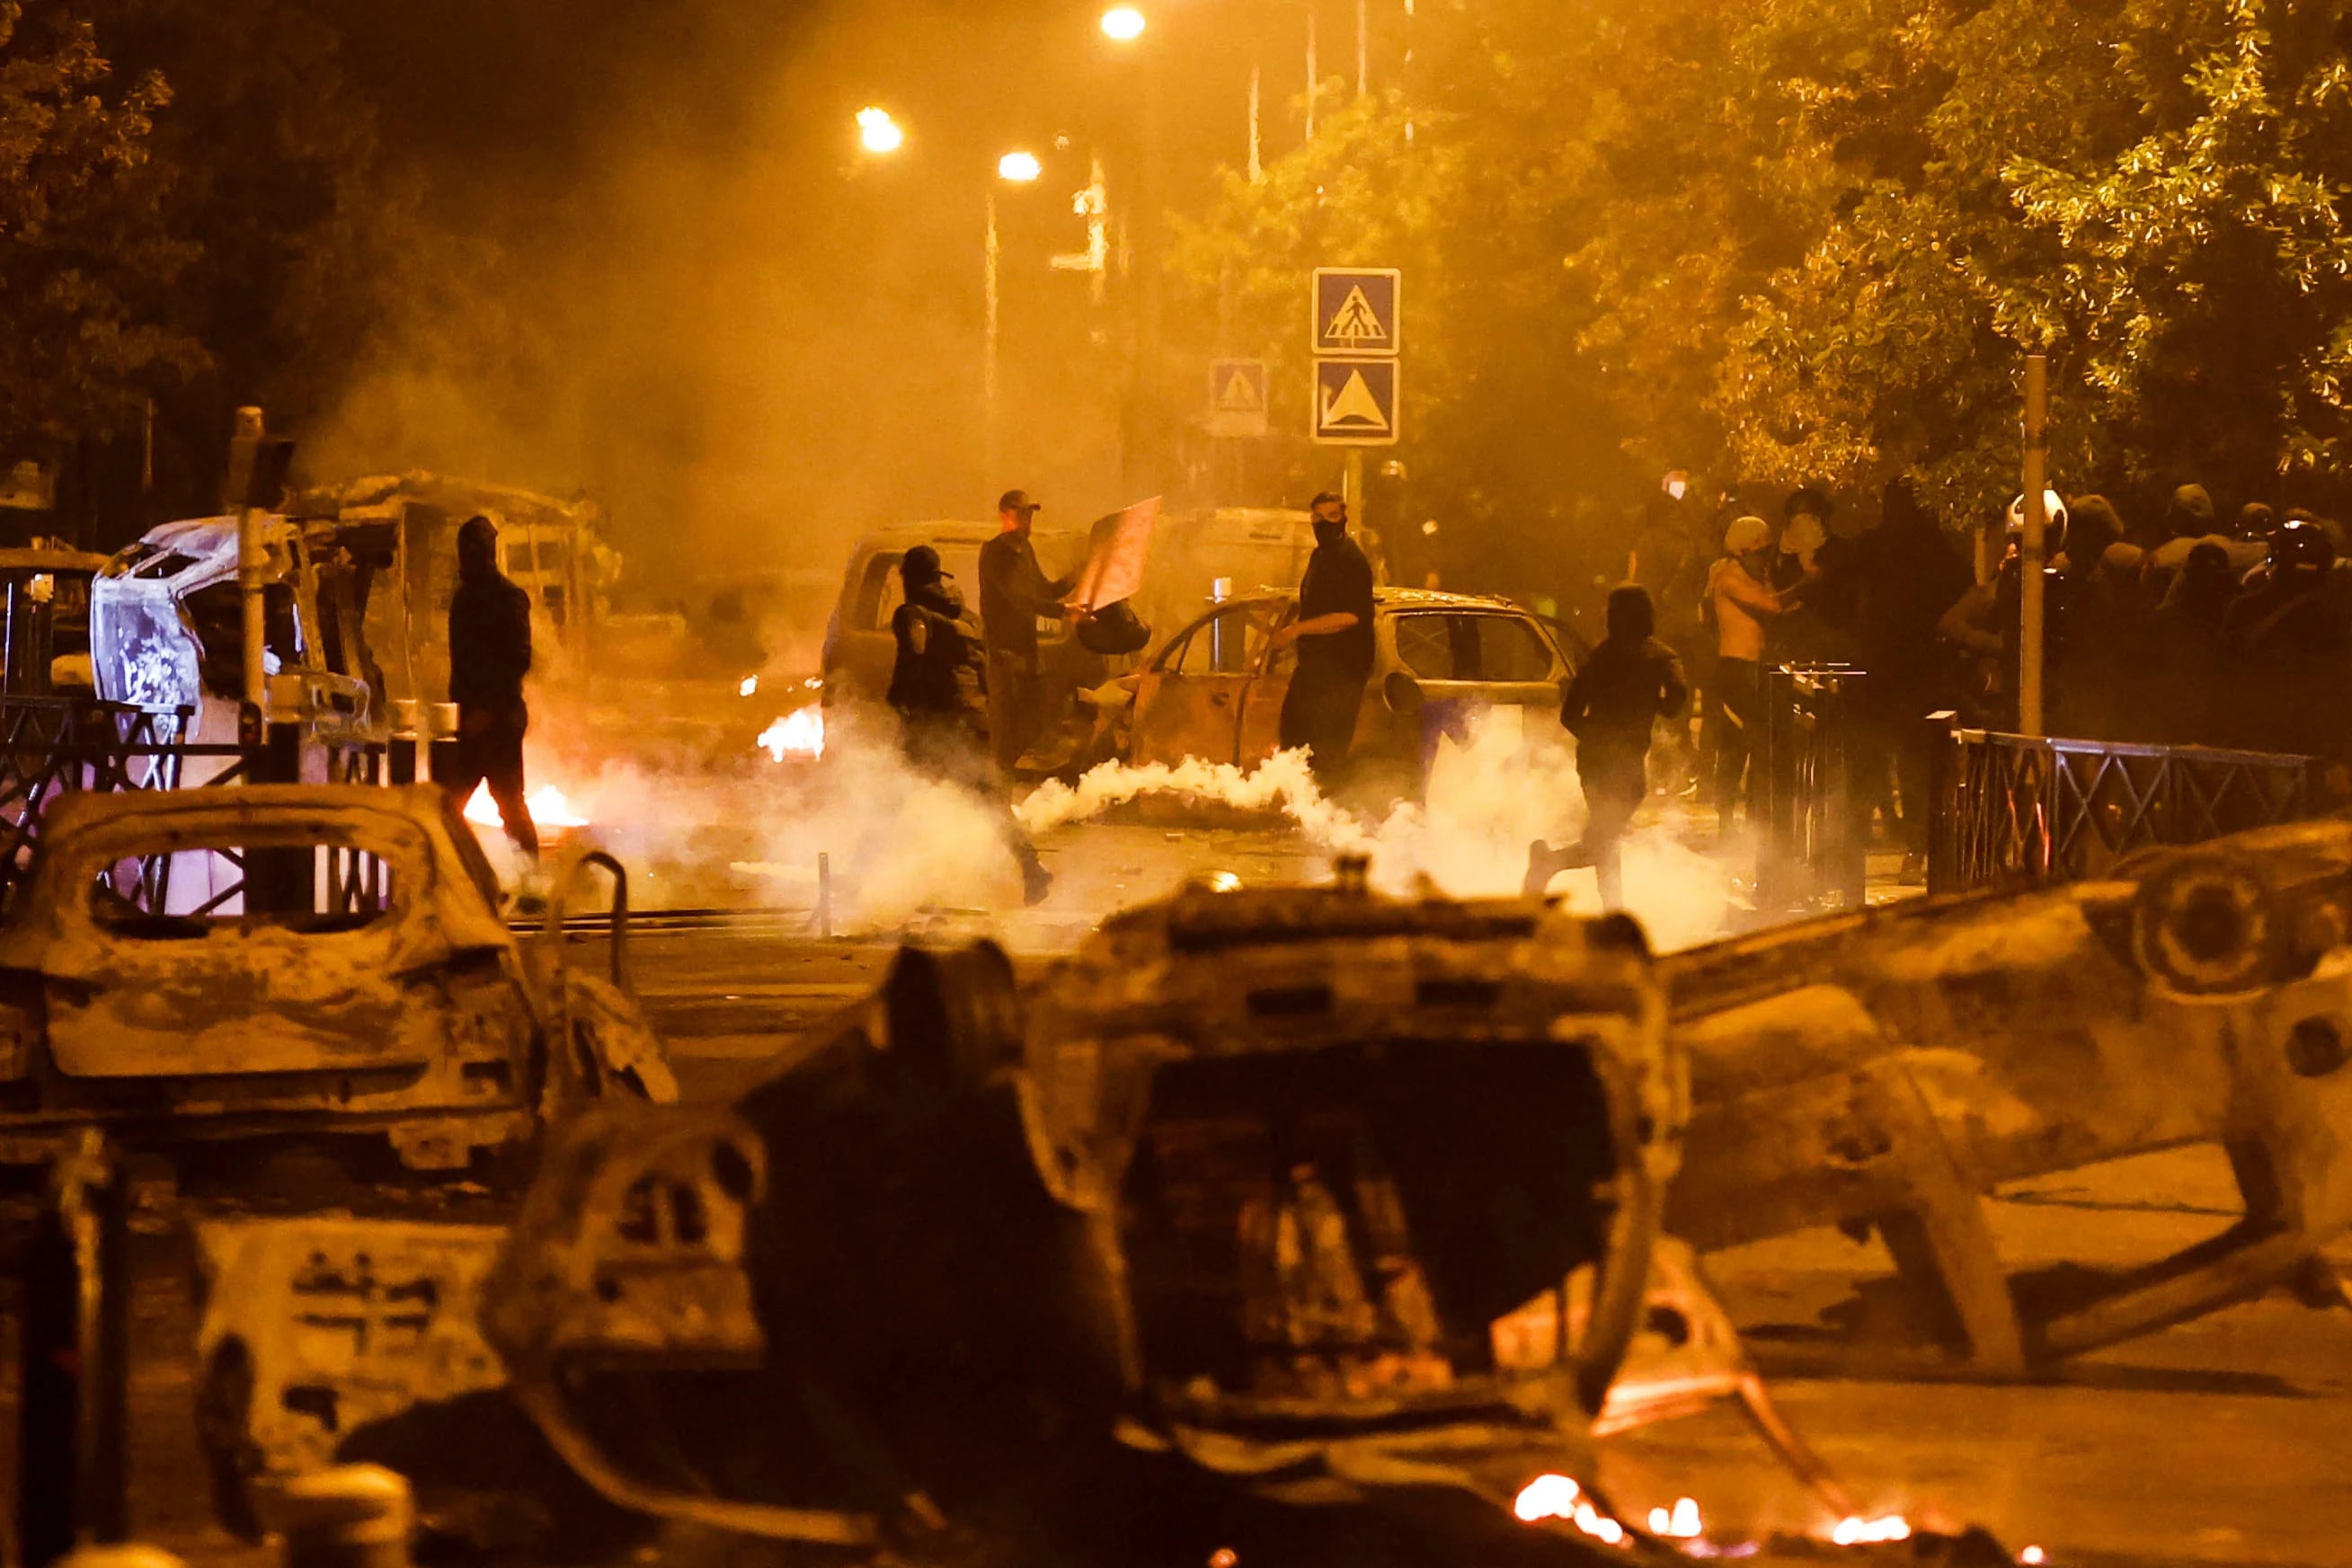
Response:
[1661,818,2352,1378]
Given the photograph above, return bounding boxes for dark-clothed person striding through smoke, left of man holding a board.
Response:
[887,545,1053,905]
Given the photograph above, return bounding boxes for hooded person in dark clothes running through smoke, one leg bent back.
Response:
[1526,583,1691,909]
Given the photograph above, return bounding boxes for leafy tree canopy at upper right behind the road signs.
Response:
[1171,0,2352,575]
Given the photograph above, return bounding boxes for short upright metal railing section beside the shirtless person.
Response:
[1750,665,1870,912]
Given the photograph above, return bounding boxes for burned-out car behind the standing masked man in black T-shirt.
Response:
[1127,588,1574,785]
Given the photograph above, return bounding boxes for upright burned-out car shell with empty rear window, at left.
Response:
[0,785,678,1168]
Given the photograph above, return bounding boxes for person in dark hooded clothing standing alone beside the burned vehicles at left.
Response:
[442,518,538,861]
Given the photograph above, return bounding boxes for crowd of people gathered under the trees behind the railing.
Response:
[1611,473,2352,883]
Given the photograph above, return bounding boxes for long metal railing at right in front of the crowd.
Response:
[1926,713,2345,893]
